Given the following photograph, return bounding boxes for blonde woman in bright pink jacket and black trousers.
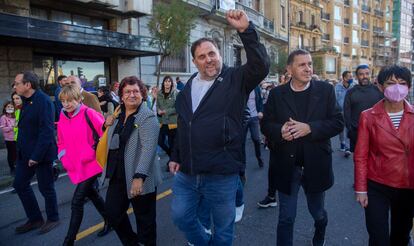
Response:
[58,85,109,245]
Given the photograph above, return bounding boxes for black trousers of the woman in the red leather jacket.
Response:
[365,181,414,246]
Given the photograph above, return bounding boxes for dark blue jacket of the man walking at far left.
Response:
[17,90,57,162]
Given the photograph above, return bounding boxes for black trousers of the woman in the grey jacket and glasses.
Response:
[105,177,157,246]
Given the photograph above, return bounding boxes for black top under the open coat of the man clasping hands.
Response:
[290,85,311,166]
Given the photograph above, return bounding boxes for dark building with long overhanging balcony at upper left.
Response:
[0,0,158,102]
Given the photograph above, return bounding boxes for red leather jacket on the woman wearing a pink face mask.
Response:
[354,99,414,192]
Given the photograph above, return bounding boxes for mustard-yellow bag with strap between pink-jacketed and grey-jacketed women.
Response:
[85,106,121,169]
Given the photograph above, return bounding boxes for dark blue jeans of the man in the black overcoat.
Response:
[277,167,328,246]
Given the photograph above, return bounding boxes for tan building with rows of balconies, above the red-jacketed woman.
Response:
[320,0,393,78]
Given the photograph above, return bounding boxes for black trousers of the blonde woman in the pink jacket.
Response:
[66,176,106,241]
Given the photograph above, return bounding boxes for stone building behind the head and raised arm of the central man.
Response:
[144,0,288,84]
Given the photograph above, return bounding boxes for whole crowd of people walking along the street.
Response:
[0,7,414,246]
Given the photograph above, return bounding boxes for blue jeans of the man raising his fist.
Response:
[171,172,236,246]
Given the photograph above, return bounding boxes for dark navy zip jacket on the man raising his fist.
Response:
[171,24,269,175]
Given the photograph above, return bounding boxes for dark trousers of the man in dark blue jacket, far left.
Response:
[13,160,59,222]
